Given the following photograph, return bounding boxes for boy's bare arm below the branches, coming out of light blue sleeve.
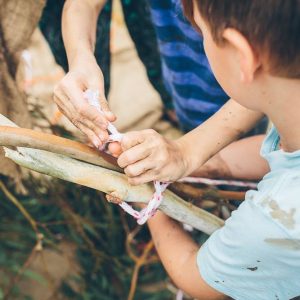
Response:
[148,212,226,300]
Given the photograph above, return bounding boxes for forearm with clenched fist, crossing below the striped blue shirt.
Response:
[118,99,263,184]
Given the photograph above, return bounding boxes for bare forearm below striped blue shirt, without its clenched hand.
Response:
[178,99,263,175]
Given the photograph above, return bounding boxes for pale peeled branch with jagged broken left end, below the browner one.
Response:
[0,116,224,234]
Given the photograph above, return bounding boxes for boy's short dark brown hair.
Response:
[182,0,300,78]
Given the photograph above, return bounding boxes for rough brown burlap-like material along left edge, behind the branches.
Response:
[0,0,45,183]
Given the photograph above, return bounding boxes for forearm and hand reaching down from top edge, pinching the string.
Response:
[54,0,115,147]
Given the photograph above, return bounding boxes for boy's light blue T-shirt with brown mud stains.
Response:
[197,128,300,300]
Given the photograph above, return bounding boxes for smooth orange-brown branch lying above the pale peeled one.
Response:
[0,126,123,173]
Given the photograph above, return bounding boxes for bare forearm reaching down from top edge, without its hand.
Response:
[62,0,106,67]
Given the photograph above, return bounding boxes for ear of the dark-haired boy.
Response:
[223,28,261,83]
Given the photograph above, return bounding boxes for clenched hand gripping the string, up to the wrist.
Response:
[109,129,188,185]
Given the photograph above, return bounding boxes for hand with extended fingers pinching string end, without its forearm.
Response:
[54,51,116,148]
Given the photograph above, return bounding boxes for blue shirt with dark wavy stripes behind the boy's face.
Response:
[148,0,229,130]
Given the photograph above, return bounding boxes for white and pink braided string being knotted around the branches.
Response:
[84,89,169,225]
